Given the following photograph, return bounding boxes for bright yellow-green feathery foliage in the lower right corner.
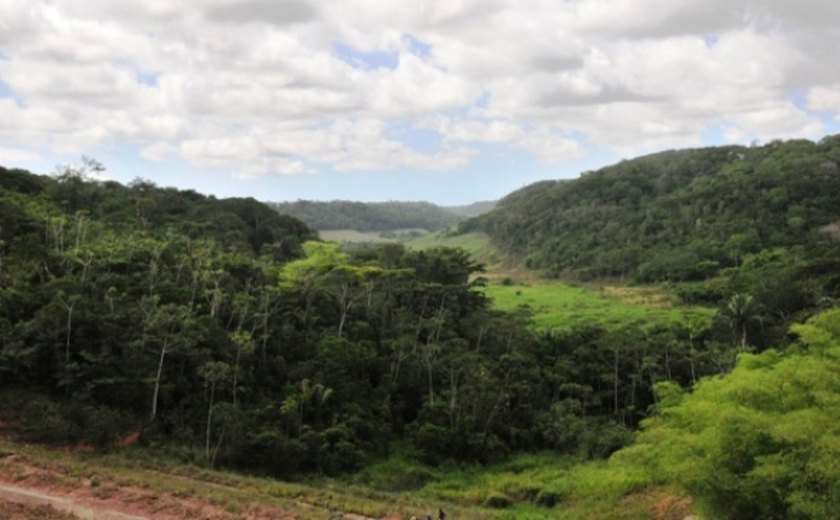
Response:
[617,309,840,519]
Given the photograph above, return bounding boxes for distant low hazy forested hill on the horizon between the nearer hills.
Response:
[269,200,493,231]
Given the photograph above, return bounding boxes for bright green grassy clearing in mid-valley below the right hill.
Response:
[485,281,715,329]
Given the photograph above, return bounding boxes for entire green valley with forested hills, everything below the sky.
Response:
[0,138,840,520]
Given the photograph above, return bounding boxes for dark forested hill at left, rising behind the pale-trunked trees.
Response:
[0,167,317,258]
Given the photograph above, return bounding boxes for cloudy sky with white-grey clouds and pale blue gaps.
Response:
[0,0,840,204]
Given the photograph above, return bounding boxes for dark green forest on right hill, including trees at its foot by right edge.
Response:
[461,136,840,354]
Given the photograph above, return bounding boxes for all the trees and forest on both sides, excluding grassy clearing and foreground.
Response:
[0,138,840,518]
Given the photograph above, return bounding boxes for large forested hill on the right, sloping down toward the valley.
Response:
[462,136,840,281]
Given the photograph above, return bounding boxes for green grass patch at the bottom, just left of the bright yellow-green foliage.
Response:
[353,453,675,520]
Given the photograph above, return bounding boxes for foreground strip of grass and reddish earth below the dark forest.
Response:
[0,434,682,520]
